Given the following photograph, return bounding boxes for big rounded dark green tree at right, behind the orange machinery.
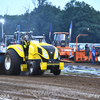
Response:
[63,0,100,42]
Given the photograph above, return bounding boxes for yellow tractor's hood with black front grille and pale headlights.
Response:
[31,41,58,59]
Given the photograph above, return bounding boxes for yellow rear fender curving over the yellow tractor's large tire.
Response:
[7,45,25,58]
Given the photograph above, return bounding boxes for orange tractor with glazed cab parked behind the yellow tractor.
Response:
[54,32,75,62]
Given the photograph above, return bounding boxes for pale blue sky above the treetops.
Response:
[0,0,100,15]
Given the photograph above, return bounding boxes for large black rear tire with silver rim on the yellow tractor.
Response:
[4,49,23,75]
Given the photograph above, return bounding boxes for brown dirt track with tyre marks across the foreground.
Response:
[0,63,100,100]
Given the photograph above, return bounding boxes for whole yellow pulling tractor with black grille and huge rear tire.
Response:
[4,32,64,75]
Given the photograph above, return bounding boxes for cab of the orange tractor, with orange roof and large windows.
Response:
[54,32,69,47]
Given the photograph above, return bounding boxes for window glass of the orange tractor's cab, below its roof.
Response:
[54,34,69,46]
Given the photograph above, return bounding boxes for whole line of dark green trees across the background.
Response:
[0,0,100,43]
